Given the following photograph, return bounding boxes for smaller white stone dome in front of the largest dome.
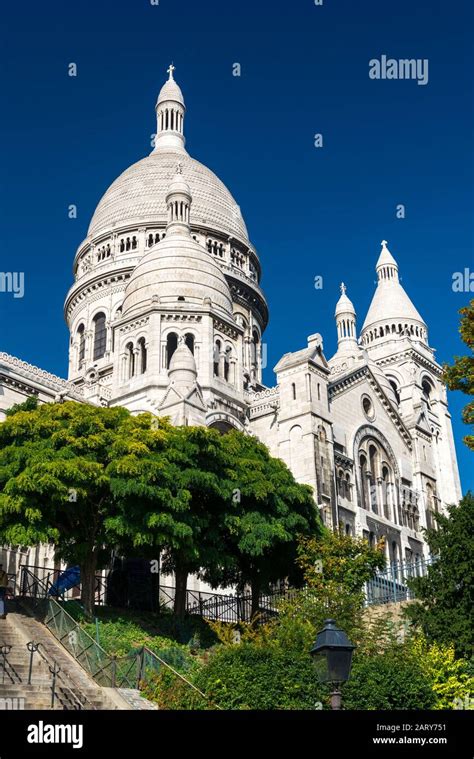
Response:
[122,234,233,318]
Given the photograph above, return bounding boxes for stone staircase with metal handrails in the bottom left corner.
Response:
[0,608,124,710]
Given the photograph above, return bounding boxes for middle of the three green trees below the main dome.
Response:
[107,427,230,617]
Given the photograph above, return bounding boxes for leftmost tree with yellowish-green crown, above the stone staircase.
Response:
[0,401,172,613]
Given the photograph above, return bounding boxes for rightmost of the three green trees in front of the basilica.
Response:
[208,430,322,614]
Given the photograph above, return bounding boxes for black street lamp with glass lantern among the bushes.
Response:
[310,619,355,709]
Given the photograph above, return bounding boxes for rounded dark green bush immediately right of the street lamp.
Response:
[343,645,435,710]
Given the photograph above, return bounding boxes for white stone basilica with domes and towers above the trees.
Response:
[0,66,461,571]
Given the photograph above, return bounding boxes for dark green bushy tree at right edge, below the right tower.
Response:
[406,493,474,658]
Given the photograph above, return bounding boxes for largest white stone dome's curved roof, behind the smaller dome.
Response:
[88,148,248,242]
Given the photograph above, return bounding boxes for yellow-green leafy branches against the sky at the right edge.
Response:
[443,300,474,450]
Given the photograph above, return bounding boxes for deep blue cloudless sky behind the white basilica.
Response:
[0,0,474,489]
